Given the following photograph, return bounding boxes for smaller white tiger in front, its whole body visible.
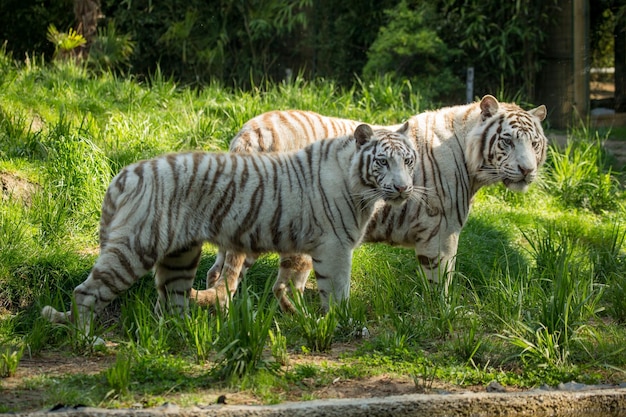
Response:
[42,125,417,334]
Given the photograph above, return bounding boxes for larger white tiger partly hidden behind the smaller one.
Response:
[192,95,547,310]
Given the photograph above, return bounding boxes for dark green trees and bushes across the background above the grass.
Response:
[0,0,560,102]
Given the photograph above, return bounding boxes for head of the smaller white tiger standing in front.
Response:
[354,123,417,205]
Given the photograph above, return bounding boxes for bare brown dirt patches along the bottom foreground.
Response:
[0,345,502,412]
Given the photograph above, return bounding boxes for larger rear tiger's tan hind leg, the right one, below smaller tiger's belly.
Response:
[272,255,313,313]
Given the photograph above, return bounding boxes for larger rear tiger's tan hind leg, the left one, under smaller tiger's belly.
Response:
[190,251,247,309]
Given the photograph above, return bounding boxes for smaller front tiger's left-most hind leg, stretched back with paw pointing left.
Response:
[41,242,153,336]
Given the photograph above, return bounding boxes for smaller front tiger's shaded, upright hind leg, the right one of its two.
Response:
[154,243,202,316]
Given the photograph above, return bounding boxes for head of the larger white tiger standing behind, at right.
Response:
[467,95,548,191]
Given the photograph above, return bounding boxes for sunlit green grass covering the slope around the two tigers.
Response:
[0,57,626,412]
